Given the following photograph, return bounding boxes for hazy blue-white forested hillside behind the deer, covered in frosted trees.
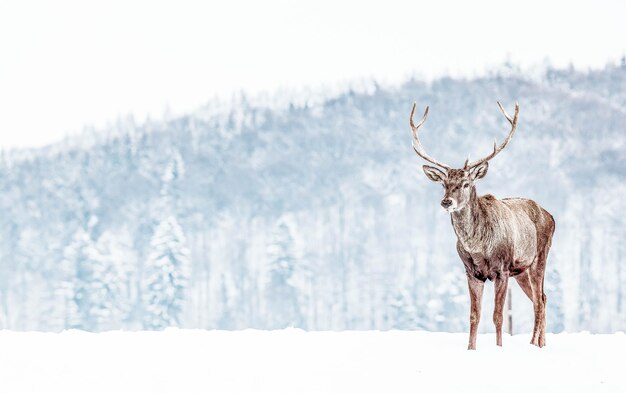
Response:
[0,65,626,332]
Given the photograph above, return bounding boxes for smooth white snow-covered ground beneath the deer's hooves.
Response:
[0,329,626,393]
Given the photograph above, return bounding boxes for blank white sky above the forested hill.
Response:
[0,0,626,148]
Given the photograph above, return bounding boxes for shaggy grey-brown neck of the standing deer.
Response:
[451,187,486,251]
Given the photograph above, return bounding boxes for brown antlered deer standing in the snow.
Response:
[409,102,555,350]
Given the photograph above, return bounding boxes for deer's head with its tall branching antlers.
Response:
[410,102,519,213]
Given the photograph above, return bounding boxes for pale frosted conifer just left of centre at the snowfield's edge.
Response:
[265,222,303,329]
